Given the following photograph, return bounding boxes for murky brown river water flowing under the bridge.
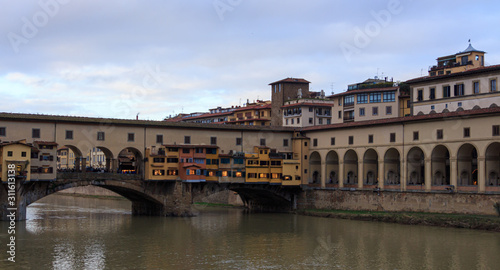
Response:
[0,195,500,270]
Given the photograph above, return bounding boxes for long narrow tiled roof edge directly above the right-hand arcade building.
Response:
[302,107,500,131]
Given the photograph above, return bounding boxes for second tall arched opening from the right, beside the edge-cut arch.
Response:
[457,143,478,186]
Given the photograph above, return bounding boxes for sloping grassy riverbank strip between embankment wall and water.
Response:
[297,209,500,232]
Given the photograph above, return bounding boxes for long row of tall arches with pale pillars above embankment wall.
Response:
[309,142,500,192]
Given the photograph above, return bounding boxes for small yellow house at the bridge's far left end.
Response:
[0,140,31,182]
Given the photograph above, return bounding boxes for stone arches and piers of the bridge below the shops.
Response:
[0,172,301,220]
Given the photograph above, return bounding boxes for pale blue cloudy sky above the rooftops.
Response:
[0,0,500,120]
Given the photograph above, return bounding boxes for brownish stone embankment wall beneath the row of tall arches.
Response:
[297,189,500,215]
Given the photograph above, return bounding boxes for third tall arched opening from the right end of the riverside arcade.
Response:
[431,145,450,186]
